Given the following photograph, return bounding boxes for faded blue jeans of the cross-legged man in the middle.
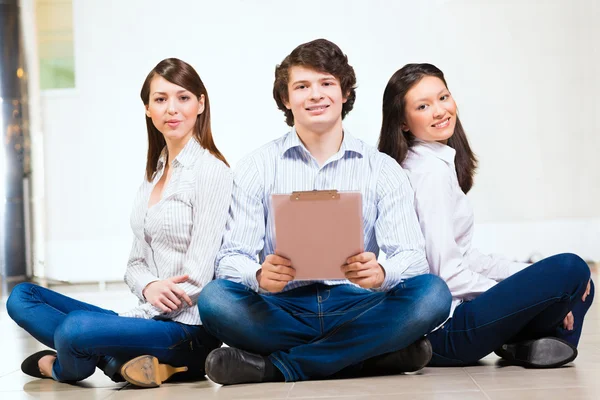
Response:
[198,275,451,382]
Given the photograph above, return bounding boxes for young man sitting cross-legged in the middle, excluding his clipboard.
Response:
[198,39,451,384]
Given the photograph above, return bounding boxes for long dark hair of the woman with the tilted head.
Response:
[378,64,477,193]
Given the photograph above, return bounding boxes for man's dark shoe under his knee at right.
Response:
[362,337,433,375]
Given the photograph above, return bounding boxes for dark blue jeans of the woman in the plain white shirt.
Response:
[428,254,594,366]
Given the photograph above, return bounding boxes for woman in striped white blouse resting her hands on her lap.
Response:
[6,58,233,387]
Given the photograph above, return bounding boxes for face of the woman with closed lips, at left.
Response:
[146,76,204,142]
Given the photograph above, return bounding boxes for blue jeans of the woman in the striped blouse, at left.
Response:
[6,283,221,382]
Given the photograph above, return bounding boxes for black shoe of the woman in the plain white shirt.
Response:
[494,337,577,368]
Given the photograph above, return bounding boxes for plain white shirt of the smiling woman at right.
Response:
[402,141,529,316]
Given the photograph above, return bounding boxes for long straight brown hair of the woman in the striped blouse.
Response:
[140,58,229,181]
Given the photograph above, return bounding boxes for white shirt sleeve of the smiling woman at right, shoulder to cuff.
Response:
[411,164,496,300]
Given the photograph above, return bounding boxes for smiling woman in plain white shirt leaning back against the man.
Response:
[379,64,594,368]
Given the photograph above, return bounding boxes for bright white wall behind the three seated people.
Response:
[42,0,600,281]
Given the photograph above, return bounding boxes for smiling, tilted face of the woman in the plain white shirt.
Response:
[402,76,456,143]
